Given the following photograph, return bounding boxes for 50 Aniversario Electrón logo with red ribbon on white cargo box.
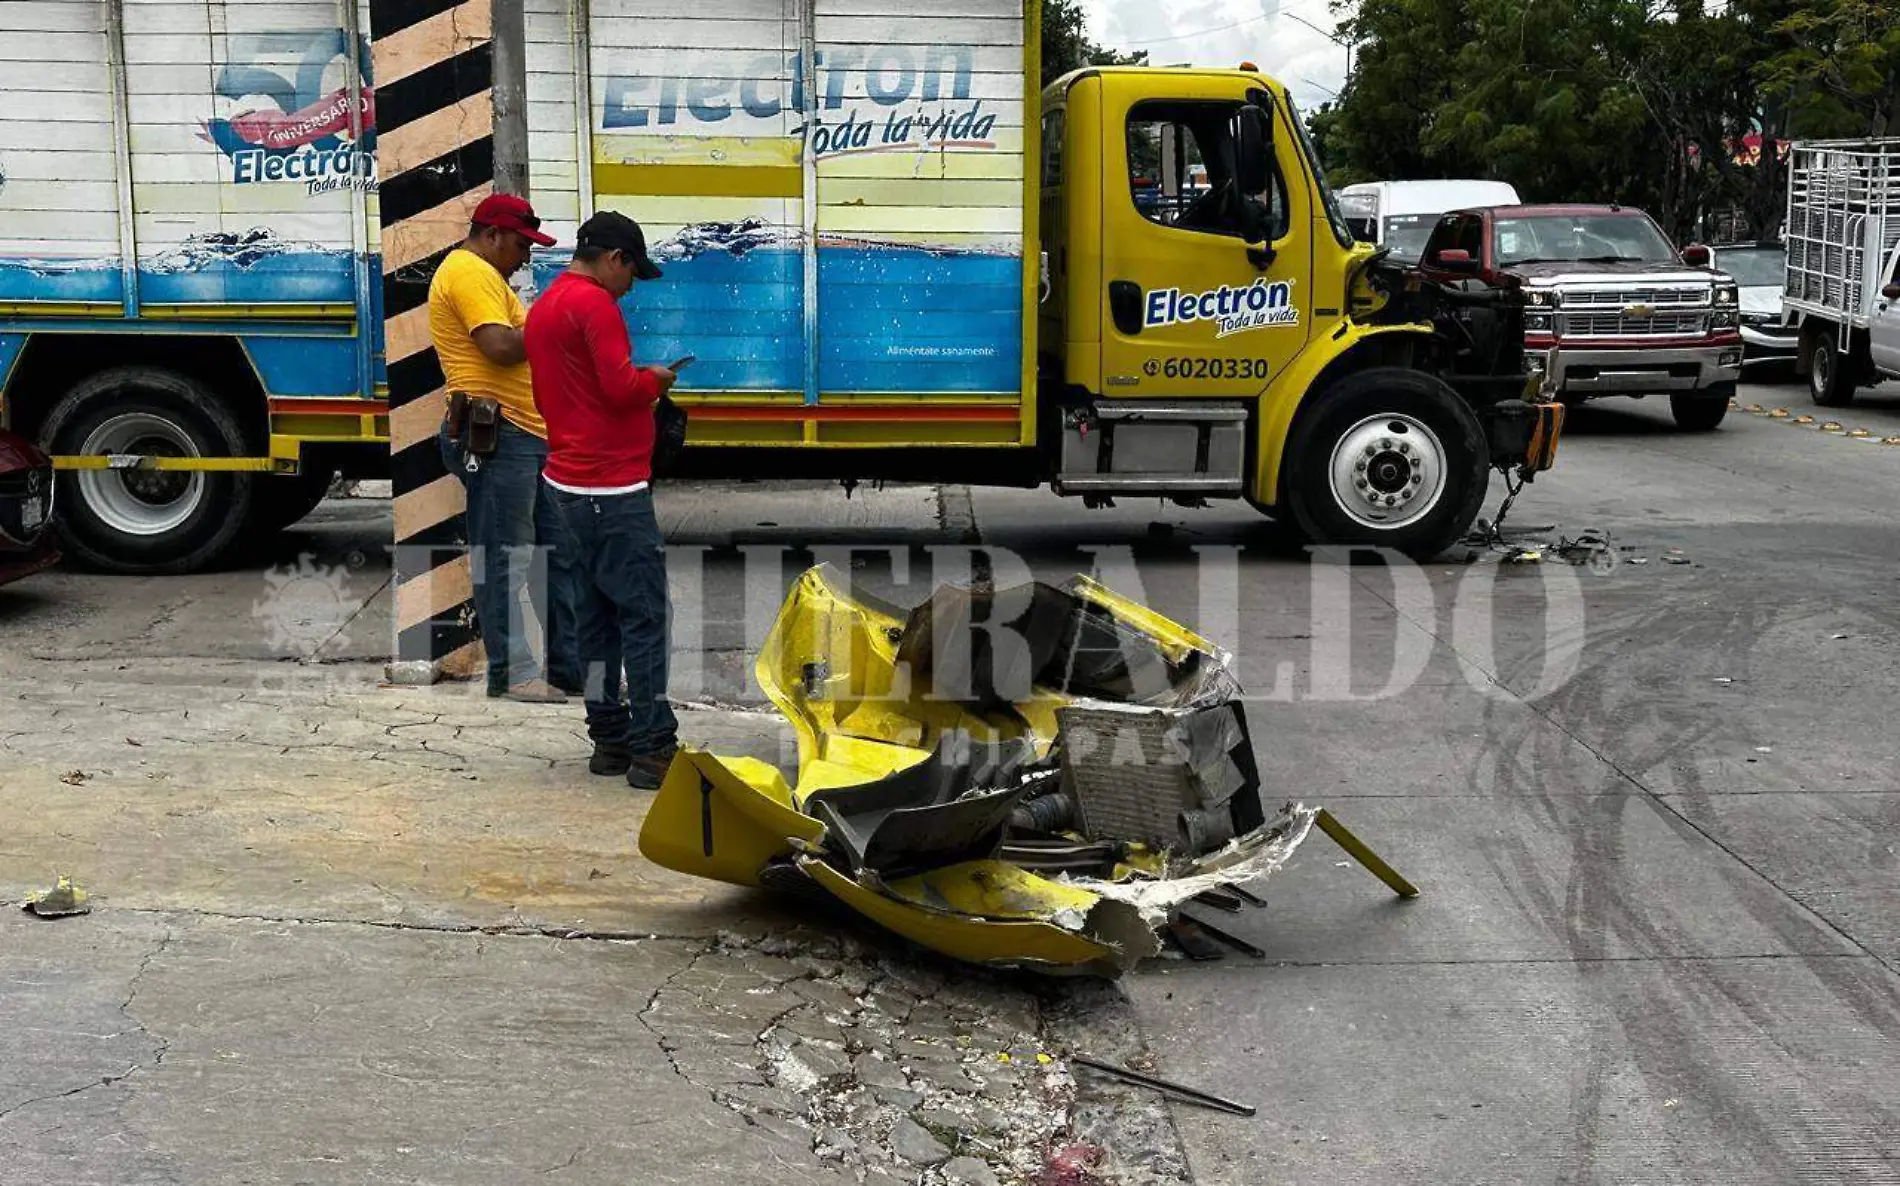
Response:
[198,29,376,196]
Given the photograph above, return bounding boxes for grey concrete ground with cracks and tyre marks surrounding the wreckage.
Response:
[0,390,1900,1186]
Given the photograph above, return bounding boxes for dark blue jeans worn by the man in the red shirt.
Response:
[547,487,678,755]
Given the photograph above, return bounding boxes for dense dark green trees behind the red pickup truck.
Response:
[1315,0,1816,238]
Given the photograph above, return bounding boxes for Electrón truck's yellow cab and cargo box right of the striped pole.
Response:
[528,0,1556,553]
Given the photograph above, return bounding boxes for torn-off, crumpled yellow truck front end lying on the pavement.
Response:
[640,566,1410,975]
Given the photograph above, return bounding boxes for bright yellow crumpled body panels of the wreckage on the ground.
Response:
[640,566,1292,975]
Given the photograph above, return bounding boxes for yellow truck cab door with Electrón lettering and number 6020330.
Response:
[1102,85,1313,399]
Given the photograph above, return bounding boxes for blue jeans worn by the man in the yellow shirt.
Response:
[439,420,580,692]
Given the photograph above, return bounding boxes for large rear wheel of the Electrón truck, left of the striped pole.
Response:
[42,367,257,574]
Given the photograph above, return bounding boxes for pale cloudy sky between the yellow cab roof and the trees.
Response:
[1083,0,1345,108]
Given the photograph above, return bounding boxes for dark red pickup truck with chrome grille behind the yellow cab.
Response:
[1419,205,1742,431]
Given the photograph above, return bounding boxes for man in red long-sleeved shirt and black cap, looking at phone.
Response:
[526,211,678,789]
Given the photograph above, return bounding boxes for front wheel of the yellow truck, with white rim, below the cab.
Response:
[1283,367,1490,559]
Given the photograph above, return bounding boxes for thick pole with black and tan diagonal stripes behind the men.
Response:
[369,0,526,682]
